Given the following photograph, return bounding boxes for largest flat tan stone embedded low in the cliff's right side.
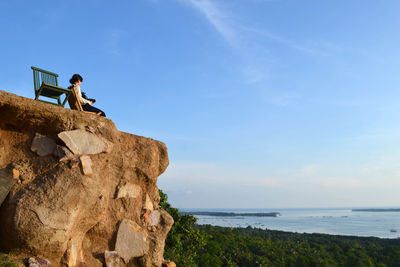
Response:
[115,219,149,263]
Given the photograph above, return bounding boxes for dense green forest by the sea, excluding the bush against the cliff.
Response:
[195,226,400,267]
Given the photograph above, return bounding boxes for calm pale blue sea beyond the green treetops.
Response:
[180,207,400,238]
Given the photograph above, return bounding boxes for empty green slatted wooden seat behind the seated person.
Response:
[31,67,71,107]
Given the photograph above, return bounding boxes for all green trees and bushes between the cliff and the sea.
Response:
[160,191,400,267]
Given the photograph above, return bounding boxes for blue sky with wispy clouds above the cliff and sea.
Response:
[0,0,400,208]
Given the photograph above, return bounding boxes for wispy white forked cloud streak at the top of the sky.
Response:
[178,0,338,83]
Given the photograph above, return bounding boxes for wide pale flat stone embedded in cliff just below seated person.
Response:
[58,129,107,155]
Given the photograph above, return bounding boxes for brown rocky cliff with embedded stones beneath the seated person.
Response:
[0,91,173,266]
